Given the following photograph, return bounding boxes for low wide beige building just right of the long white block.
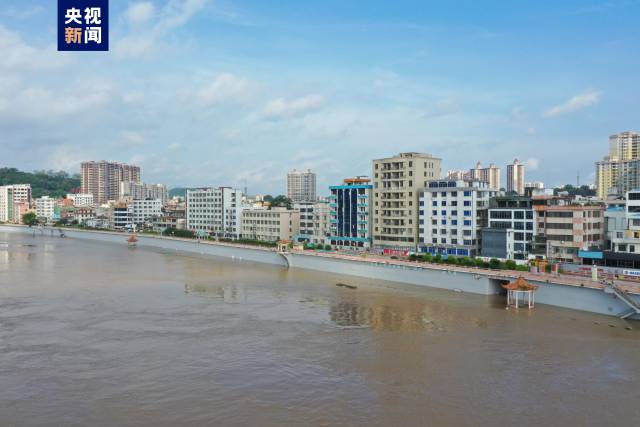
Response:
[242,208,300,242]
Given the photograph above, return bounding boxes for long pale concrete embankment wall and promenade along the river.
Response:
[0,225,640,316]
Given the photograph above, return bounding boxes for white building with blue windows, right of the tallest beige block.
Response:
[419,180,496,256]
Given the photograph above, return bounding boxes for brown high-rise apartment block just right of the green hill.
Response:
[80,160,140,205]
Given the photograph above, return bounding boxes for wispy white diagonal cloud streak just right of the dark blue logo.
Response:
[113,0,207,57]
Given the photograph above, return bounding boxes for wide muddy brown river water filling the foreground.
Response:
[0,232,640,426]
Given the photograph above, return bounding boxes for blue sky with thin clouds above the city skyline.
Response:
[0,0,640,193]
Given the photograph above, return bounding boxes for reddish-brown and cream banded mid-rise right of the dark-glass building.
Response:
[532,196,605,263]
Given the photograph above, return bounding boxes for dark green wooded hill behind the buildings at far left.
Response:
[0,168,80,198]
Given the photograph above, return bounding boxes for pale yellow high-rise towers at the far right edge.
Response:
[596,132,640,200]
